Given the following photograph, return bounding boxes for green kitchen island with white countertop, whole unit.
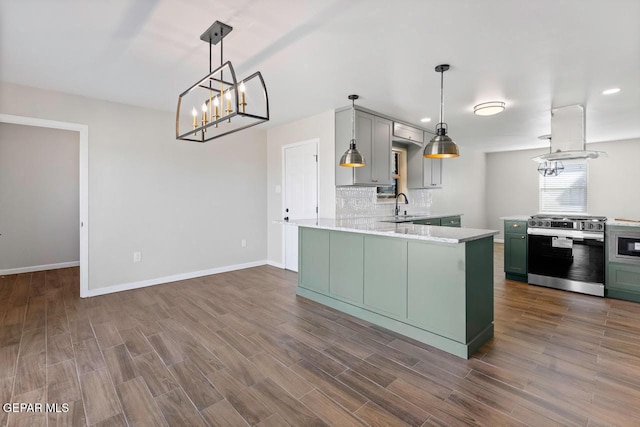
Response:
[292,219,498,359]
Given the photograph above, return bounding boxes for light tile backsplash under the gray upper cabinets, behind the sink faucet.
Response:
[336,187,433,219]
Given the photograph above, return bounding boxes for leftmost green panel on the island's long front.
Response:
[298,227,329,293]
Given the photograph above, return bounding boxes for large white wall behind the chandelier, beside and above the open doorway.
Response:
[0,83,267,290]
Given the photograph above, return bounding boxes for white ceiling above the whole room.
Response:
[0,0,640,151]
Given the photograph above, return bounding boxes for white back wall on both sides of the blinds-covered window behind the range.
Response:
[486,139,640,238]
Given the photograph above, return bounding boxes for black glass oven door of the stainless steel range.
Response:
[528,230,604,284]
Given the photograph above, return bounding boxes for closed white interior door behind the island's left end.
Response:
[283,140,318,271]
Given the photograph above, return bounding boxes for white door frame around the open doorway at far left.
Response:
[0,114,89,298]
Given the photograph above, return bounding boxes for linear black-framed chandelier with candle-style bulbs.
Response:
[176,21,269,142]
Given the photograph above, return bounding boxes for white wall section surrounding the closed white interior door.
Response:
[266,110,336,265]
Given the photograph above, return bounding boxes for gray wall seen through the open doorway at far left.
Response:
[0,123,80,271]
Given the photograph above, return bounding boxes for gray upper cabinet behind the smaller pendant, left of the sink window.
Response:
[336,108,393,187]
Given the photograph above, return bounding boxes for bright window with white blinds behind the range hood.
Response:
[540,161,587,213]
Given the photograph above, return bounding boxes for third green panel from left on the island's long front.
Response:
[364,235,407,319]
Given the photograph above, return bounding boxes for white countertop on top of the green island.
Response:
[289,221,498,243]
